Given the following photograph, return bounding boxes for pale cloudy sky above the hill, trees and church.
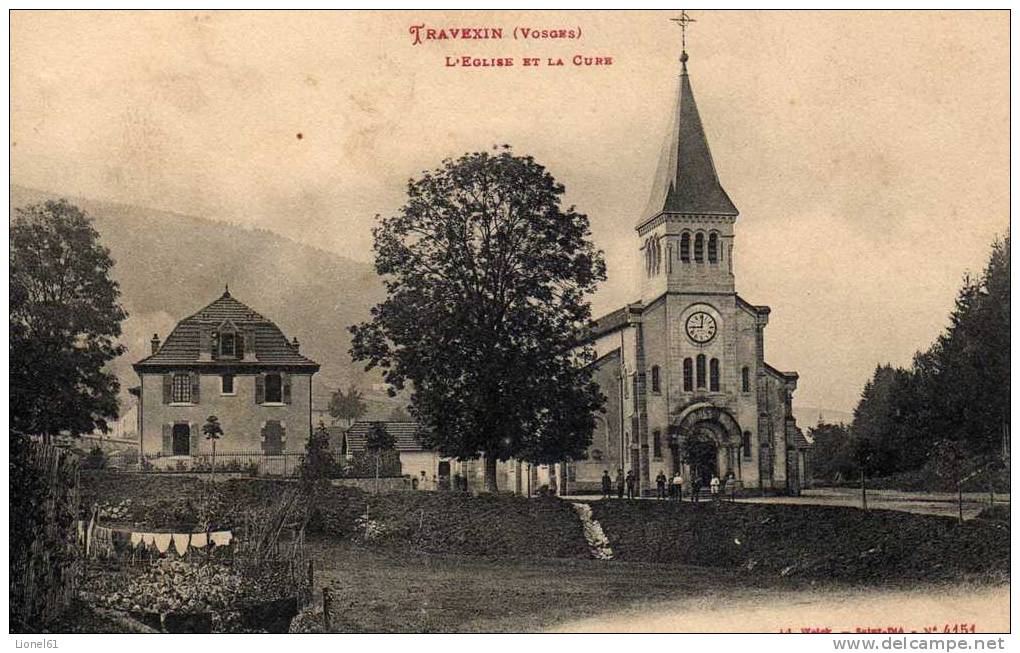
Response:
[10,11,1010,410]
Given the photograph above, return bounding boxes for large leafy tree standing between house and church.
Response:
[351,146,605,491]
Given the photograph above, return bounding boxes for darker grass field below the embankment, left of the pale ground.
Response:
[309,538,822,633]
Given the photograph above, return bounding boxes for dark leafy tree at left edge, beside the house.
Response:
[10,200,126,440]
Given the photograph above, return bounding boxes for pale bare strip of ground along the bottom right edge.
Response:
[554,586,1010,633]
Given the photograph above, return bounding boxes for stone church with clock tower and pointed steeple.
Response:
[565,51,810,494]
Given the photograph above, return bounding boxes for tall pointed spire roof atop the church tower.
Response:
[639,50,738,225]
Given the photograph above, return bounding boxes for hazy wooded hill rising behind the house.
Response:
[10,186,384,405]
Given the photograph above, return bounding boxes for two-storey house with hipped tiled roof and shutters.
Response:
[134,289,319,467]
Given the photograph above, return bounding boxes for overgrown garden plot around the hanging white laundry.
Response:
[81,479,312,633]
